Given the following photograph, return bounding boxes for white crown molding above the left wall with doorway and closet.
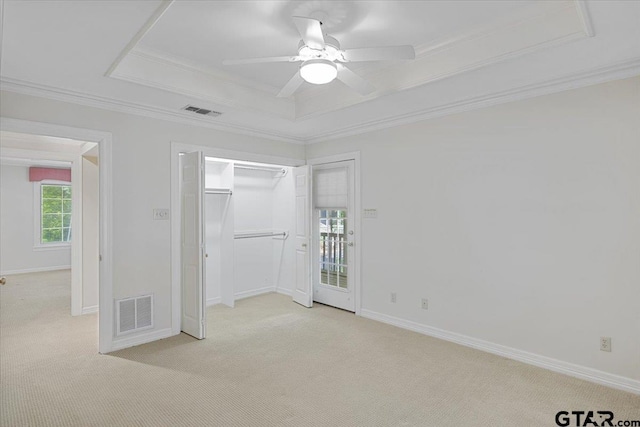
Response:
[0,77,306,144]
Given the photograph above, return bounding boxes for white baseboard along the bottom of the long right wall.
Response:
[360,309,640,394]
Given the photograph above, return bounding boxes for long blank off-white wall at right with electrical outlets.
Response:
[307,78,640,380]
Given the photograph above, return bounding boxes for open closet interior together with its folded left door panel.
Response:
[179,152,295,339]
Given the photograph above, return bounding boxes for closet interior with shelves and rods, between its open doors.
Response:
[204,157,293,307]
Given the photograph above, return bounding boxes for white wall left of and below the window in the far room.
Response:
[0,164,71,275]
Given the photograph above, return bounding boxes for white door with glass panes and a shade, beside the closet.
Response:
[312,161,356,311]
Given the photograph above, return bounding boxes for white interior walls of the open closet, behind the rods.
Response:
[205,162,294,305]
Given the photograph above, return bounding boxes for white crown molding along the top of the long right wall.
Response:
[306,58,640,144]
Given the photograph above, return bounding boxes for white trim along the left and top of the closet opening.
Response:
[169,141,304,335]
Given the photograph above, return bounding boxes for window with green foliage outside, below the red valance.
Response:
[40,183,71,245]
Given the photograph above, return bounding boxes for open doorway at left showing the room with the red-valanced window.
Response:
[0,130,100,352]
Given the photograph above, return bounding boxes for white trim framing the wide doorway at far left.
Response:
[0,117,114,353]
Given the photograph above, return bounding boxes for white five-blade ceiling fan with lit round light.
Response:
[222,16,415,98]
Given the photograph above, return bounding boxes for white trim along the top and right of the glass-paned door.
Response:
[307,151,362,316]
